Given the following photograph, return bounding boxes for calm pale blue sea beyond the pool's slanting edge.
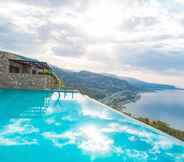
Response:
[126,90,184,130]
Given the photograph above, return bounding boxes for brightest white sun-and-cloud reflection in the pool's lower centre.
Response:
[43,125,124,159]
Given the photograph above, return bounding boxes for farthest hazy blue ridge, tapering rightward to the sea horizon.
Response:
[103,74,177,91]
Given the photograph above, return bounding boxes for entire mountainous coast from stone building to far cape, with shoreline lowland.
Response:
[53,67,175,110]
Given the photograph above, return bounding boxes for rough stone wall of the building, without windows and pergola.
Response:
[0,51,60,89]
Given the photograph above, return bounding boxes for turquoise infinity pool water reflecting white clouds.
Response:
[0,90,184,162]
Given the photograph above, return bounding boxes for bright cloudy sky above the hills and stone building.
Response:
[0,0,184,87]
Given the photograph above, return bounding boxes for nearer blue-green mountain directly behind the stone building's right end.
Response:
[54,67,136,99]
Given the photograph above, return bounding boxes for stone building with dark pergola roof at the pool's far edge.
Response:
[0,51,63,89]
